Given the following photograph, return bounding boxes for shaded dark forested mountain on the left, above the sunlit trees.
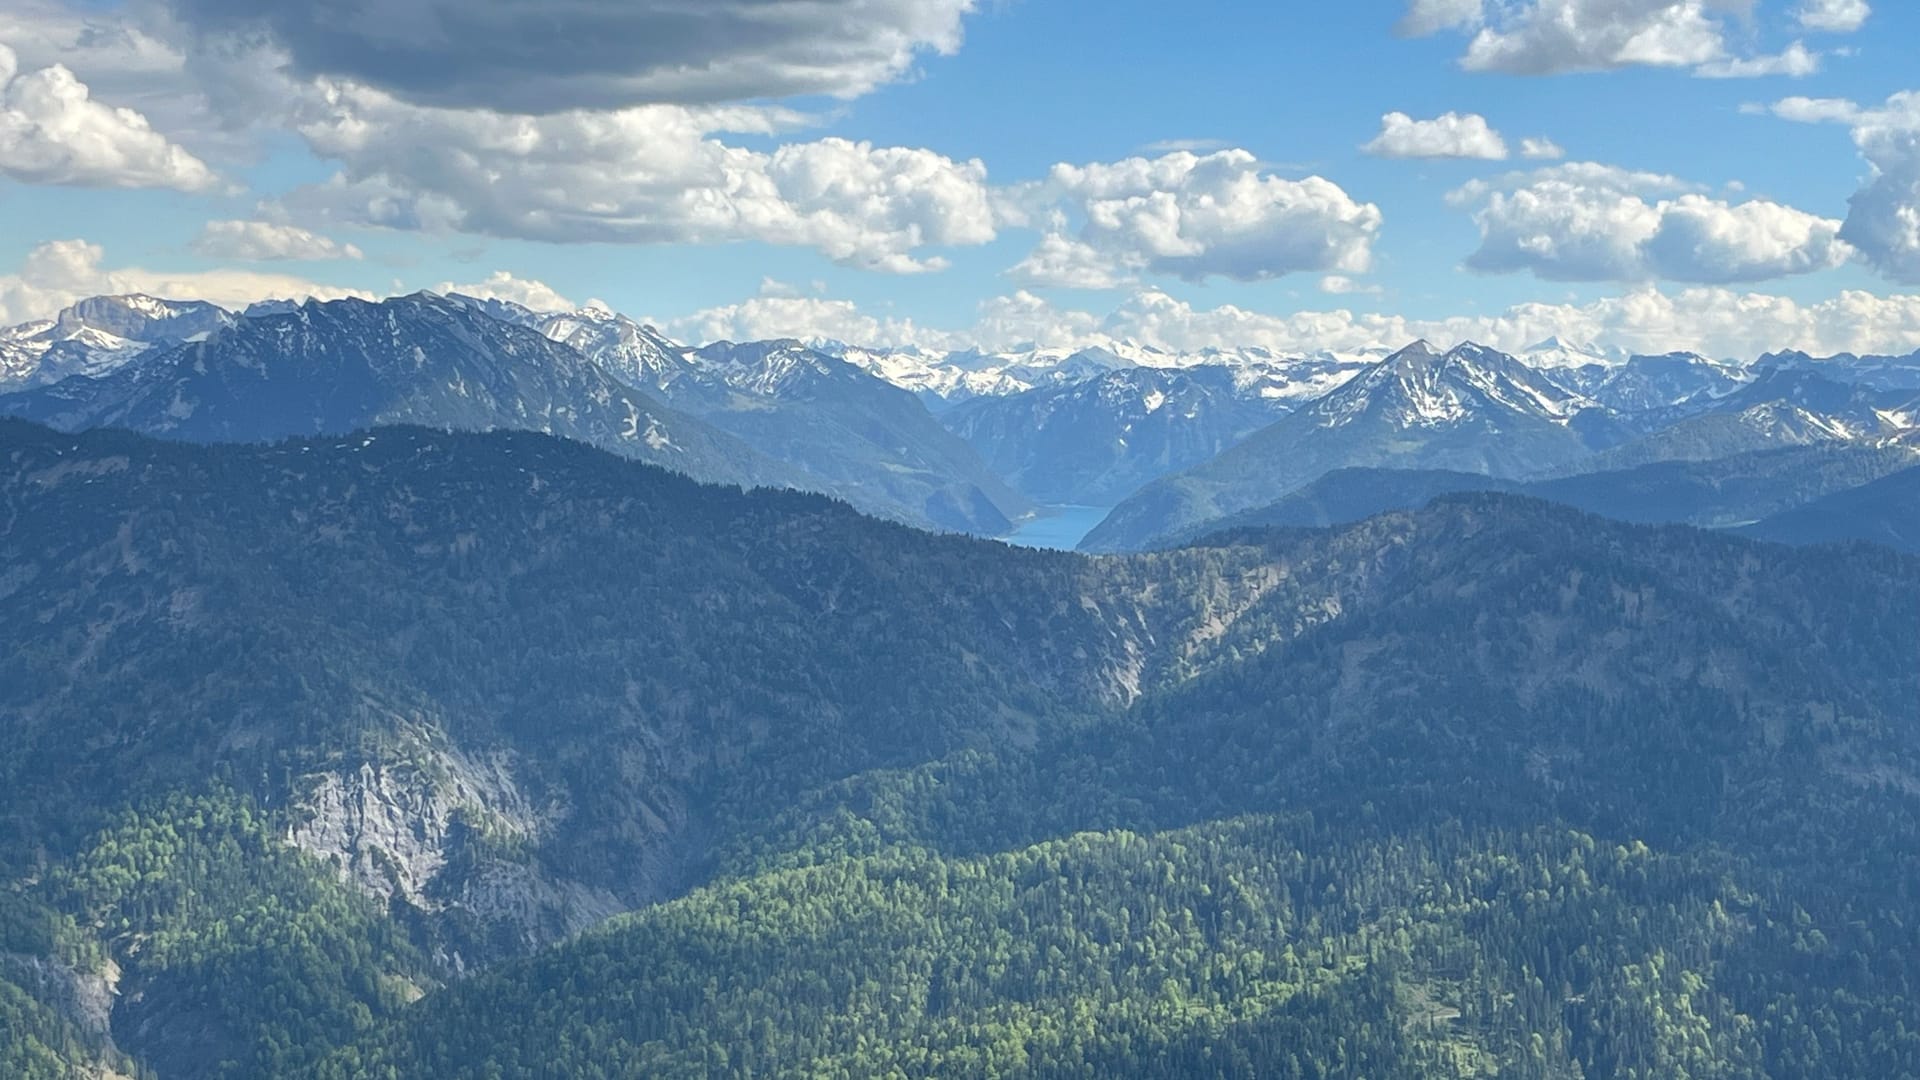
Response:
[0,423,1152,924]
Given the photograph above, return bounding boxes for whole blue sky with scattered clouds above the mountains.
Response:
[0,0,1920,356]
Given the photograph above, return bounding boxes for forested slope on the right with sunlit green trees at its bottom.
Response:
[321,496,1920,1078]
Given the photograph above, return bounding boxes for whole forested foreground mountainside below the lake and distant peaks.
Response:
[0,423,1920,1080]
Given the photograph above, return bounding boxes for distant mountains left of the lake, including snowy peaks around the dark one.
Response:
[0,294,1031,534]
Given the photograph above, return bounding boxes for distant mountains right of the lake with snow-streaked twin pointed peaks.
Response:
[1085,346,1920,550]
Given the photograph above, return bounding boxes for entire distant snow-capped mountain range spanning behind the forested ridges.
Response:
[0,294,1920,550]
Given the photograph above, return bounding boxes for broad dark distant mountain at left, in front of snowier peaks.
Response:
[0,294,801,486]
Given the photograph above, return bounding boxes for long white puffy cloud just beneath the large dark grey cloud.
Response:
[286,85,995,273]
